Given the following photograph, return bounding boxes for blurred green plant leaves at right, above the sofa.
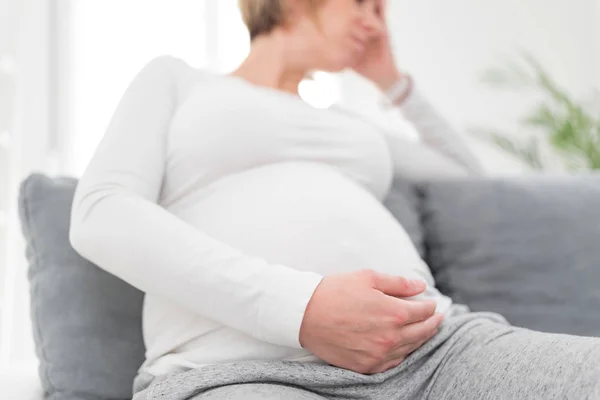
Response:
[478,54,600,171]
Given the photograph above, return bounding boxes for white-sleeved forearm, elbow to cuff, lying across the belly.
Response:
[71,189,321,347]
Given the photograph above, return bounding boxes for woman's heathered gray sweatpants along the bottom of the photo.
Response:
[134,306,600,400]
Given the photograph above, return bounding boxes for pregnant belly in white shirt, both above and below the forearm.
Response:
[144,164,451,374]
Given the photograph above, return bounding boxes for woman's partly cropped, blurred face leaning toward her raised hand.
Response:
[301,0,384,71]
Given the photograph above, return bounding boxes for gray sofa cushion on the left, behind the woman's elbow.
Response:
[19,174,145,400]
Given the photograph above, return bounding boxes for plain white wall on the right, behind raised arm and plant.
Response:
[340,0,600,172]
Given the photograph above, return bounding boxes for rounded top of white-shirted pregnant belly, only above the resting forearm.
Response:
[175,164,432,283]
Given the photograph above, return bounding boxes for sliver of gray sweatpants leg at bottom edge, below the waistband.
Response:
[192,383,325,400]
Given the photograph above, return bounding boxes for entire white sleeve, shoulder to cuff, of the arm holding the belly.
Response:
[70,56,322,348]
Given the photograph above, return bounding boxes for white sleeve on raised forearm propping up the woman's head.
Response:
[397,87,482,175]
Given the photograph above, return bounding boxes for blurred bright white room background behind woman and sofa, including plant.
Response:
[0,0,600,372]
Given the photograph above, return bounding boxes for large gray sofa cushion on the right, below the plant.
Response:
[420,176,600,336]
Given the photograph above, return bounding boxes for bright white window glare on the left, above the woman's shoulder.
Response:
[63,0,206,175]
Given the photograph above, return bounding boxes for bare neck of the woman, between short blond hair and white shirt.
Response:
[232,30,308,94]
